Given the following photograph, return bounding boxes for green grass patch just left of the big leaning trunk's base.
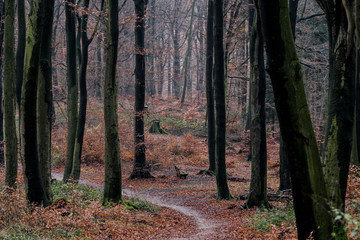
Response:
[250,204,295,232]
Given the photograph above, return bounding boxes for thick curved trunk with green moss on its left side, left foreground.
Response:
[20,0,49,206]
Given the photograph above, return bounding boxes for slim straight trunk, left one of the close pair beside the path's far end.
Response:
[63,0,78,182]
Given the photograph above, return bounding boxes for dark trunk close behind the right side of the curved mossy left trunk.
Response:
[37,0,55,201]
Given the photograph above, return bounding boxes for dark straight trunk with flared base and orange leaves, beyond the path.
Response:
[130,0,152,178]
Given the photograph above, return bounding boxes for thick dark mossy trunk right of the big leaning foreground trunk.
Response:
[317,0,355,214]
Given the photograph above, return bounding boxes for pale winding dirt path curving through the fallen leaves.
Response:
[52,172,222,240]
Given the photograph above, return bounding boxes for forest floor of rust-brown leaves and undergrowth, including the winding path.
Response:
[0,97,360,239]
